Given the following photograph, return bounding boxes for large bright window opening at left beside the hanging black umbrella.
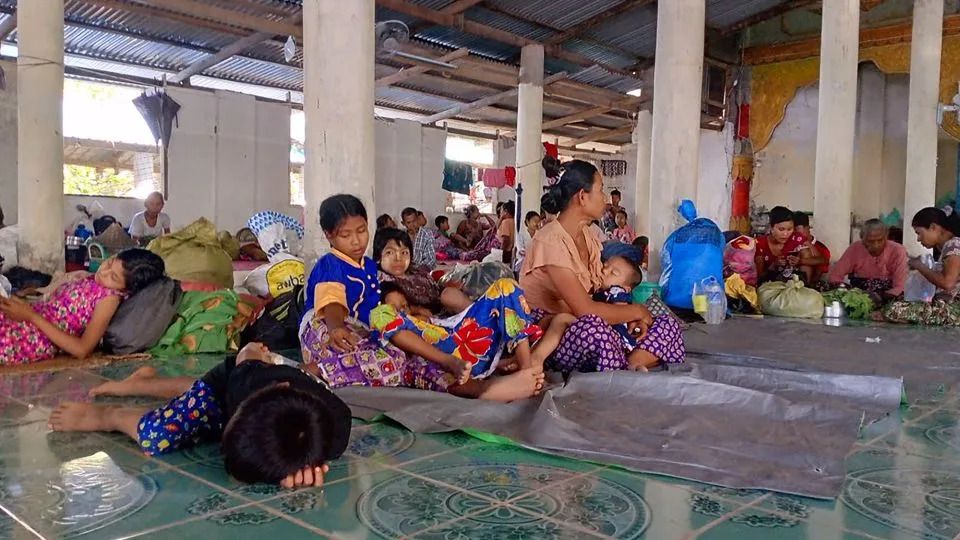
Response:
[63,79,162,198]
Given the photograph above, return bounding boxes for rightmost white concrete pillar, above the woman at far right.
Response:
[903,0,943,255]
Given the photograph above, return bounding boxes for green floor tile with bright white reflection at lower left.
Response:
[0,462,251,538]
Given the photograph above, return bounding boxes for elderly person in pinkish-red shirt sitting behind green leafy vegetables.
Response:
[828,219,908,299]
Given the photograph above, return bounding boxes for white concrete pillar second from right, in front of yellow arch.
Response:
[813,0,860,253]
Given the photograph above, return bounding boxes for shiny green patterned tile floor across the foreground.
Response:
[0,359,960,540]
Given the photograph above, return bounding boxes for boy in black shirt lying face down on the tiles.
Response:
[49,343,351,488]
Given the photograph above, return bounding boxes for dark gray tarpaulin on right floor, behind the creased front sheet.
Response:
[684,318,960,400]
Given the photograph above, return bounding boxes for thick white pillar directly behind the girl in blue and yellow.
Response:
[303,0,377,262]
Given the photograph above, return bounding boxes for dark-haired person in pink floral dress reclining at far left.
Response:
[0,249,165,366]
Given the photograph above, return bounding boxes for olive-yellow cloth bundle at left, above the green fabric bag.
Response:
[147,218,240,291]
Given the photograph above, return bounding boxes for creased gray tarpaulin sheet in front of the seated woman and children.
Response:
[337,365,902,498]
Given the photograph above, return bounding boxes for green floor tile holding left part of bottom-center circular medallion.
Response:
[258,470,500,539]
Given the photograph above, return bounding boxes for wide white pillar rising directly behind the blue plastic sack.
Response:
[648,0,705,276]
